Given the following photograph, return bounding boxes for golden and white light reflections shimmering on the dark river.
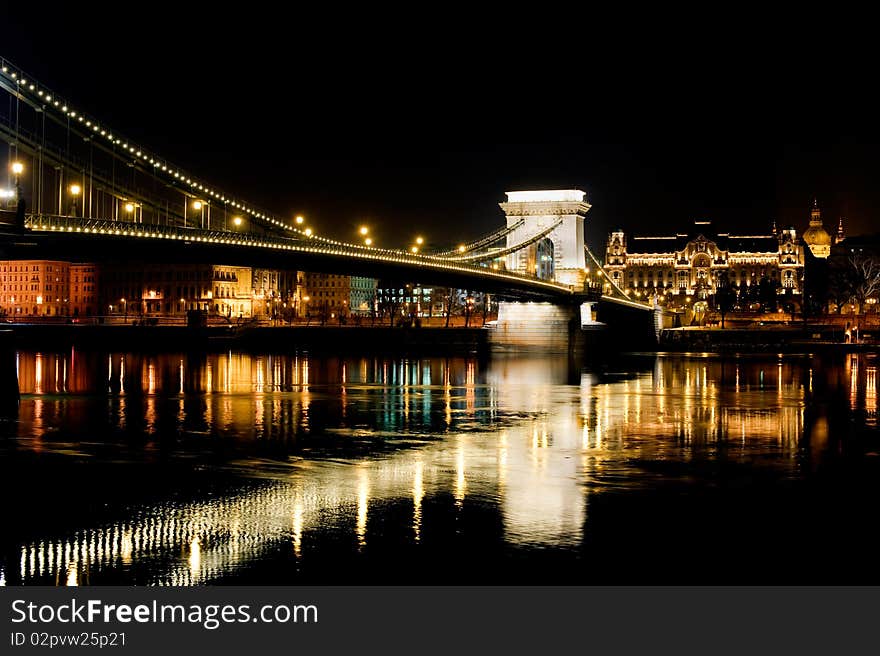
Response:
[0,351,877,585]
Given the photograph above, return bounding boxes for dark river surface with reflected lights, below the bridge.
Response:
[0,351,880,585]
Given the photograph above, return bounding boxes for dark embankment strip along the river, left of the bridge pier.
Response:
[7,324,488,355]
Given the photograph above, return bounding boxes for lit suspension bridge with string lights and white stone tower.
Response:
[0,58,653,348]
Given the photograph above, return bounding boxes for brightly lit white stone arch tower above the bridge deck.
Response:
[500,189,590,287]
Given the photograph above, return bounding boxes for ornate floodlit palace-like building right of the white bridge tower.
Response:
[605,221,804,302]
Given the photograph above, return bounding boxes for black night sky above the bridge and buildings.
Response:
[0,9,880,252]
